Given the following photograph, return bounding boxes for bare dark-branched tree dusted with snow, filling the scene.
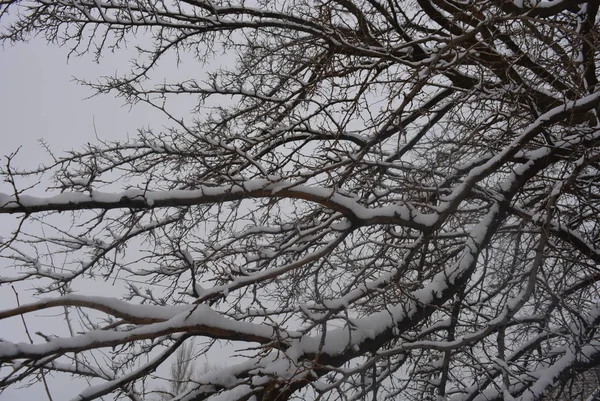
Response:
[0,0,600,401]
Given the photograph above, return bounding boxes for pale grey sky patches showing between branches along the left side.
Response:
[0,39,188,401]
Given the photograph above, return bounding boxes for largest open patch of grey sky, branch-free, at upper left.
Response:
[0,40,148,167]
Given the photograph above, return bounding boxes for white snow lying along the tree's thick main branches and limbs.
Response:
[0,76,598,400]
